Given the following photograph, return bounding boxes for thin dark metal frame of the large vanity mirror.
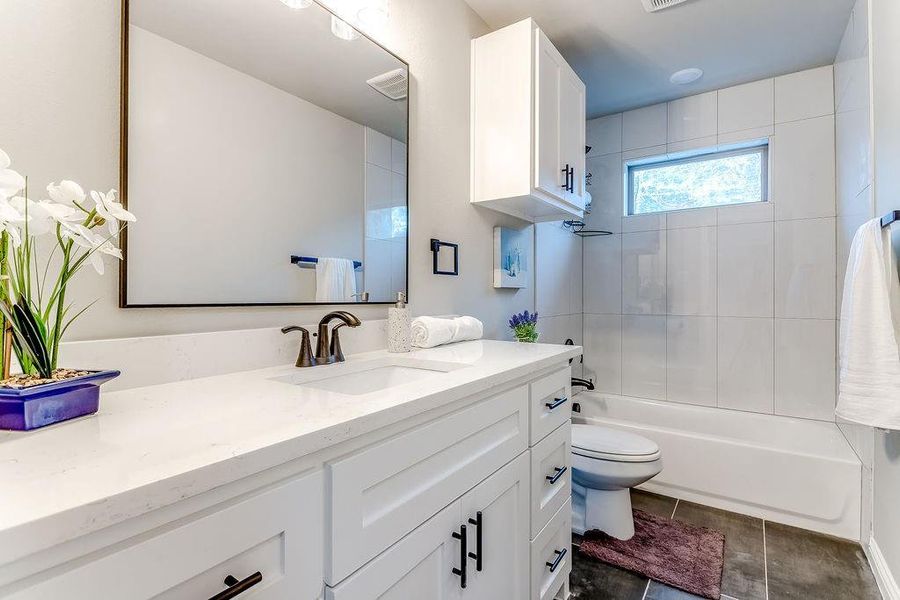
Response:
[119,0,413,308]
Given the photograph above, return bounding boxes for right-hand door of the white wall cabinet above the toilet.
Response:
[559,65,586,208]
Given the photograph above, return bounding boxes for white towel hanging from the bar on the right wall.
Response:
[835,219,900,429]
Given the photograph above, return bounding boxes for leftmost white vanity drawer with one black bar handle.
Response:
[7,471,323,600]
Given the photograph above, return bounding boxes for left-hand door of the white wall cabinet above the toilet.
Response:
[534,30,567,200]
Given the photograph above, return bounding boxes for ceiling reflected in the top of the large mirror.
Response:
[129,0,406,140]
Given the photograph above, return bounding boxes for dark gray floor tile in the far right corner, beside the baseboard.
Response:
[764,521,881,600]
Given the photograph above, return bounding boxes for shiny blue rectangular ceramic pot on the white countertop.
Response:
[0,371,120,431]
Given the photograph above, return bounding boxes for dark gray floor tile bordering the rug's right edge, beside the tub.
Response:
[675,501,766,600]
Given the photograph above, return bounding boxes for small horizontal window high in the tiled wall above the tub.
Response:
[627,143,769,215]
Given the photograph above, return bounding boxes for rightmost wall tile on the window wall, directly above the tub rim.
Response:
[775,319,836,421]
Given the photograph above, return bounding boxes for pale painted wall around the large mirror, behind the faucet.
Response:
[0,0,534,342]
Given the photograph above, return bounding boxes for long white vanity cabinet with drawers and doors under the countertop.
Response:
[0,346,571,600]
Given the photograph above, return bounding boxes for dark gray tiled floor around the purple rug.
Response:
[571,490,881,600]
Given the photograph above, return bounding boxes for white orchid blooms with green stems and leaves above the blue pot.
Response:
[0,149,135,379]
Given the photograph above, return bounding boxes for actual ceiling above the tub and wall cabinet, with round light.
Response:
[466,0,854,118]
